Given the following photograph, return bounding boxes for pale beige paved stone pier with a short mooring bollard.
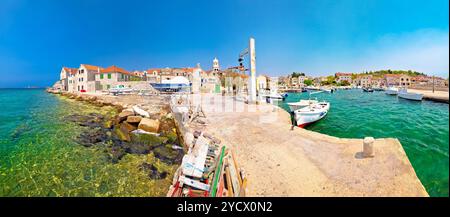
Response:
[191,96,428,196]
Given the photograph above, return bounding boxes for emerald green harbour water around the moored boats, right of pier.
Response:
[279,89,449,196]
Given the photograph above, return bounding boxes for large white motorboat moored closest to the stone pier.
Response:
[294,102,330,128]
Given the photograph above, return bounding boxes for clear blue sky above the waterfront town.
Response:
[0,0,449,87]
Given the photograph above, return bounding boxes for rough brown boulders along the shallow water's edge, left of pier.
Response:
[48,90,184,179]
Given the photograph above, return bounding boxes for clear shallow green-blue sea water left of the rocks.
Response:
[0,89,176,196]
